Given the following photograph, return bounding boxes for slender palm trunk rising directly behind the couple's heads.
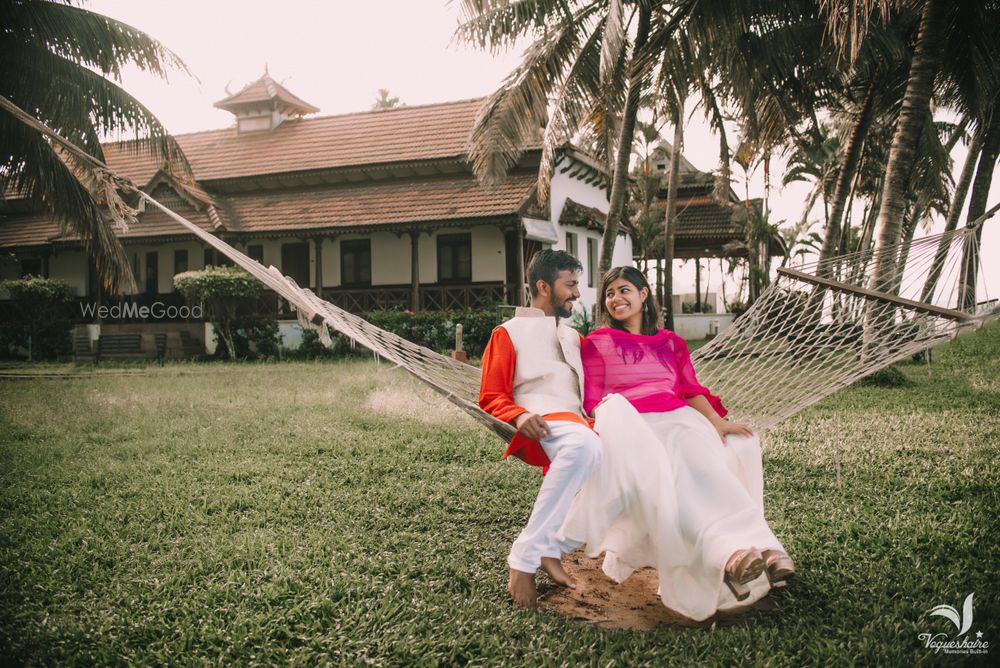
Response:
[600,2,652,274]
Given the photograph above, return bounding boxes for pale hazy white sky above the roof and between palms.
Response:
[85,0,1000,306]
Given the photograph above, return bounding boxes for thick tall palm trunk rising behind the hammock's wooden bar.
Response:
[870,0,950,290]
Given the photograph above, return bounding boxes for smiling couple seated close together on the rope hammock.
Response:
[479,250,794,621]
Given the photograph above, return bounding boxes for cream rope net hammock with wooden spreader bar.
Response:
[0,96,1000,440]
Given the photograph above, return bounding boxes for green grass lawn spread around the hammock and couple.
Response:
[0,325,1000,666]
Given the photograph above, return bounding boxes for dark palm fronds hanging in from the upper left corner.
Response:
[0,0,187,292]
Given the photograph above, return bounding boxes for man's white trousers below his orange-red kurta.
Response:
[507,420,601,573]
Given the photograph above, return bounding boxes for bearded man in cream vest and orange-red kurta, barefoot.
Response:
[479,250,601,608]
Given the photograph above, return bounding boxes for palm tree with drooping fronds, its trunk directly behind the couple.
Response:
[456,0,698,271]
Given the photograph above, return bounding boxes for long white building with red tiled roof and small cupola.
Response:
[0,73,631,326]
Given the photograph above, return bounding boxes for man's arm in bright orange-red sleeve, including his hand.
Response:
[479,327,549,440]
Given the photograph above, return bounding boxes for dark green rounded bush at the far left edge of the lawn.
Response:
[0,276,73,360]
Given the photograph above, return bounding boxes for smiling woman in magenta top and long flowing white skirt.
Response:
[562,267,794,620]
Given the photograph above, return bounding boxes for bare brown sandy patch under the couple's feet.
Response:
[539,550,773,631]
